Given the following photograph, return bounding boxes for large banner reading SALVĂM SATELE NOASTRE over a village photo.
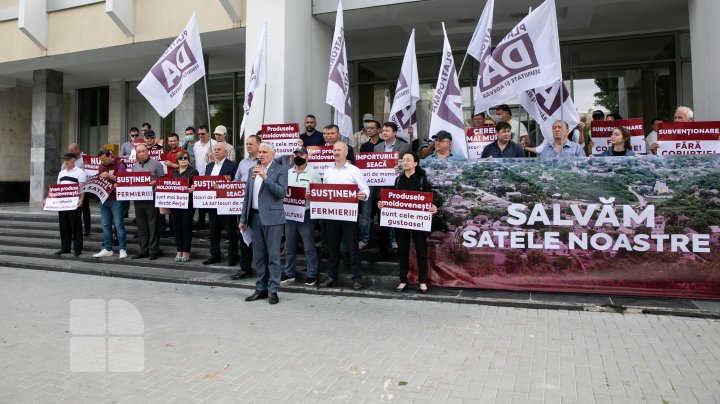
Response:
[411,155,720,299]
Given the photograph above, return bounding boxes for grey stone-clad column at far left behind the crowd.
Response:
[30,69,64,202]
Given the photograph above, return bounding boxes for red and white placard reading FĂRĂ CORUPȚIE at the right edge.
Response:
[657,121,720,156]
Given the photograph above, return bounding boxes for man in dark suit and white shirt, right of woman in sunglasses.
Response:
[203,143,238,267]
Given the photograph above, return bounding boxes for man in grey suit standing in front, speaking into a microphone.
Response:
[238,142,288,304]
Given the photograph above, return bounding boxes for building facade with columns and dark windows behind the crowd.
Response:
[0,0,720,201]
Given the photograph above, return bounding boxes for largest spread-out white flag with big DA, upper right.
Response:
[475,0,562,113]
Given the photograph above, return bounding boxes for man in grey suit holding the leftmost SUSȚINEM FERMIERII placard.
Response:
[132,144,165,260]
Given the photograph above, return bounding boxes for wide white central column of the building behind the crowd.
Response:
[238,0,333,145]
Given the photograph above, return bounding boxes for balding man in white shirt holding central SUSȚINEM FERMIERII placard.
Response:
[318,142,370,290]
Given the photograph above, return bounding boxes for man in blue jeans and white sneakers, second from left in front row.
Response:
[93,149,127,258]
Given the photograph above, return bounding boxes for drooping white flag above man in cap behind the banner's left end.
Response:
[430,23,468,159]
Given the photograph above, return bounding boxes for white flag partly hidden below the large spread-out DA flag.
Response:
[518,80,580,144]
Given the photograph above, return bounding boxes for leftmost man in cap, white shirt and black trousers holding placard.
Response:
[50,153,87,257]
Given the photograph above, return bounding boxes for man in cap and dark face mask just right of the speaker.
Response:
[280,147,322,286]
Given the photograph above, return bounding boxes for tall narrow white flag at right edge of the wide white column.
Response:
[325,1,353,139]
